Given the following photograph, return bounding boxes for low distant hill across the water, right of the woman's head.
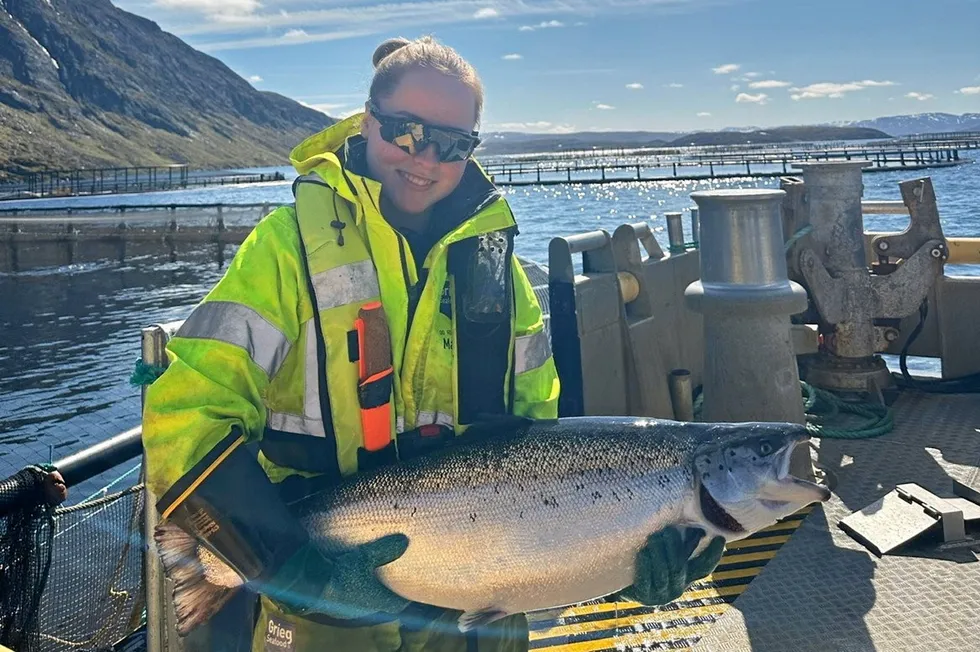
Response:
[479,126,889,156]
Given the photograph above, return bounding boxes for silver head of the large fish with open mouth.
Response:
[694,423,830,540]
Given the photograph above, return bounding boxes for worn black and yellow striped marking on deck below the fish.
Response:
[527,508,810,652]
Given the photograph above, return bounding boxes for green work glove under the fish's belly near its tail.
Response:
[256,534,409,619]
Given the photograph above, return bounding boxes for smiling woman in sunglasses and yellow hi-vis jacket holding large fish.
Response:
[143,38,720,652]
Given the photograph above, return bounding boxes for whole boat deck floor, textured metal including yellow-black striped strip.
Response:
[529,390,980,652]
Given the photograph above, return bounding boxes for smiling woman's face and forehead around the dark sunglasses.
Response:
[361,68,476,214]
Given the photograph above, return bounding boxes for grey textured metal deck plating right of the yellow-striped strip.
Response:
[693,392,980,652]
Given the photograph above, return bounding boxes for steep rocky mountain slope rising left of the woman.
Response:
[0,0,335,179]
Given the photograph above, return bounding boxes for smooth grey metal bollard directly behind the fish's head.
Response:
[684,189,807,426]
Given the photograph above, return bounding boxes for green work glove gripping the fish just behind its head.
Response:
[619,526,725,606]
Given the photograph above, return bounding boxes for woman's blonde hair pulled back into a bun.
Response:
[369,36,483,122]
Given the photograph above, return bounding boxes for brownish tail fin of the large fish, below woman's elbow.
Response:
[153,524,243,636]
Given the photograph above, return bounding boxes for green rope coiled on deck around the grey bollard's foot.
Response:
[694,380,895,439]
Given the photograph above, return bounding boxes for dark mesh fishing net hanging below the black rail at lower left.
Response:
[0,471,145,652]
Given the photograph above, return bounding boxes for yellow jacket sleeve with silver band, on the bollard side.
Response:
[512,256,560,419]
